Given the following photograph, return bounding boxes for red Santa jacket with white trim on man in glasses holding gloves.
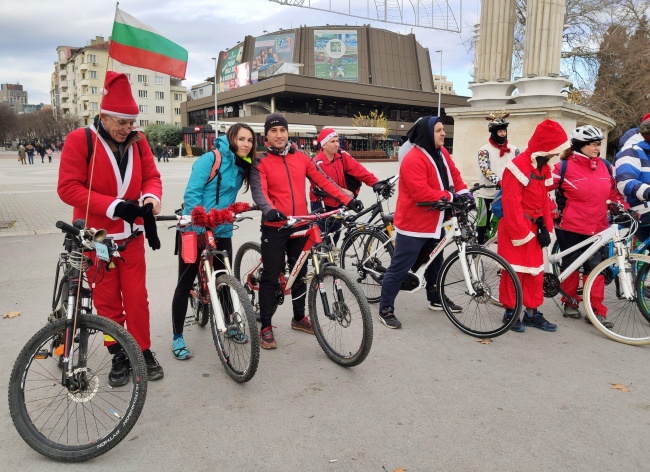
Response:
[57,126,162,240]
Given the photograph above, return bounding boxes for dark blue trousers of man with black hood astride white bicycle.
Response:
[379,233,443,312]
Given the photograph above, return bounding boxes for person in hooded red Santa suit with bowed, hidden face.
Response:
[498,120,569,332]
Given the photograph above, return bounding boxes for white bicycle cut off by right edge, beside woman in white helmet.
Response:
[544,202,650,345]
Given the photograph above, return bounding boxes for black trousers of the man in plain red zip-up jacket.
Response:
[260,226,307,329]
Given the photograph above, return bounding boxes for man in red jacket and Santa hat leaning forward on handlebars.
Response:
[309,128,384,243]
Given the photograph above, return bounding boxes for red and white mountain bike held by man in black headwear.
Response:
[234,209,373,367]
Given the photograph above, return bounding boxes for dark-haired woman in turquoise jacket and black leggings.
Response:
[172,123,257,360]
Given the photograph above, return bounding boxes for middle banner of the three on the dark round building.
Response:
[251,33,295,80]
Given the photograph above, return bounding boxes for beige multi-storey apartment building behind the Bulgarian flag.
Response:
[50,36,187,128]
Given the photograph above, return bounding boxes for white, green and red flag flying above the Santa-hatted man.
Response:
[108,8,187,79]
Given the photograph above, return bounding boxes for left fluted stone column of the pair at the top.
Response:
[474,0,515,82]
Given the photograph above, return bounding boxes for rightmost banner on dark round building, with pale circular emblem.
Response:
[314,30,359,82]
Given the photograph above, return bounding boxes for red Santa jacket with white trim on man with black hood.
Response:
[395,146,468,238]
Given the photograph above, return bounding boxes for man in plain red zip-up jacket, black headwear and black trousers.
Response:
[250,113,363,349]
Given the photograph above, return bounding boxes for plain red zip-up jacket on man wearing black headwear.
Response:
[250,148,352,226]
